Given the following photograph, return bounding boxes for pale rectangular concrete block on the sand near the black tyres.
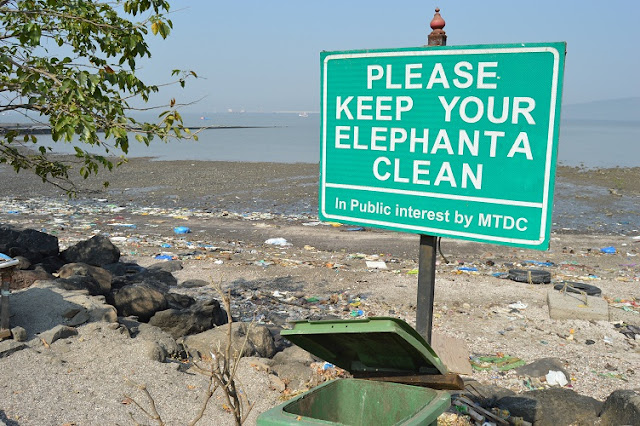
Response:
[547,290,609,321]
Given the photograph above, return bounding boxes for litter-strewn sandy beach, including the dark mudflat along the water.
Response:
[0,159,640,425]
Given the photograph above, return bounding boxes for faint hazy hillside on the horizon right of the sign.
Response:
[562,98,640,123]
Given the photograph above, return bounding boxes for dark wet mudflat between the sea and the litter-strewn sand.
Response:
[0,158,640,235]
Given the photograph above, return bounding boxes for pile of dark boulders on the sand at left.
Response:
[0,226,227,338]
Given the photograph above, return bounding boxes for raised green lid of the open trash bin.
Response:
[280,317,447,374]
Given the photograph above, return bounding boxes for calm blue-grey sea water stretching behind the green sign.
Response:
[6,113,640,168]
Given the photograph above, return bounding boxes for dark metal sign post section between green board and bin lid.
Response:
[416,235,438,344]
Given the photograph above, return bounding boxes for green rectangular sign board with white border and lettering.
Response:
[319,43,565,250]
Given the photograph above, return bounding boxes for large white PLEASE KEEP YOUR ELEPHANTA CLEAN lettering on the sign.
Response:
[333,61,536,190]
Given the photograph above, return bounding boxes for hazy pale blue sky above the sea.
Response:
[141,0,640,113]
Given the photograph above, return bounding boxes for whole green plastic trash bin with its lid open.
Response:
[257,317,451,426]
